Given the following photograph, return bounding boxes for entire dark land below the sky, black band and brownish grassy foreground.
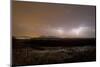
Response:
[12,38,96,66]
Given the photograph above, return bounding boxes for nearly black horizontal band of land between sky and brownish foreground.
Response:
[12,37,96,48]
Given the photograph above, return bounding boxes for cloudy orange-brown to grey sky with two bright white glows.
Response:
[12,1,96,38]
